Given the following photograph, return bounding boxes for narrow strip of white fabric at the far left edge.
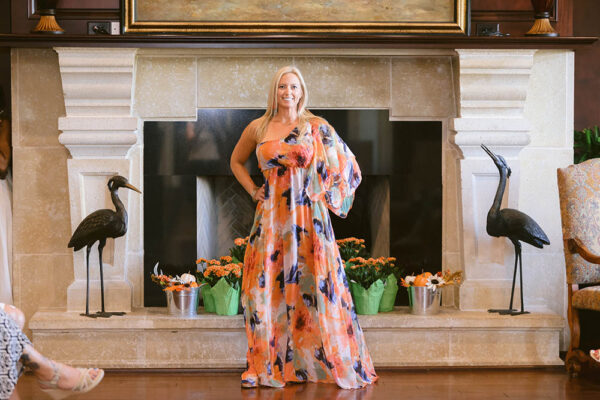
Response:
[0,172,13,304]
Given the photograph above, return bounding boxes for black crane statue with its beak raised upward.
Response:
[481,144,550,315]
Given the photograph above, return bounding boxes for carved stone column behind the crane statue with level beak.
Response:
[55,48,143,312]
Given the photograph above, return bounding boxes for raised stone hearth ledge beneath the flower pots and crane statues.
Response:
[30,307,563,368]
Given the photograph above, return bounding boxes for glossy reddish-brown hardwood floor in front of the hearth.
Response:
[11,368,600,400]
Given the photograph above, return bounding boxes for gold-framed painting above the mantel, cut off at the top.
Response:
[123,0,469,35]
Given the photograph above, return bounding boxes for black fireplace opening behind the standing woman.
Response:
[144,109,442,307]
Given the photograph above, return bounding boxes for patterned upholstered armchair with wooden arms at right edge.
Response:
[558,159,600,375]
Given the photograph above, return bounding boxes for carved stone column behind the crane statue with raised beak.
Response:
[450,49,536,310]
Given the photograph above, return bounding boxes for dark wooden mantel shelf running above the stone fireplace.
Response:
[0,34,598,49]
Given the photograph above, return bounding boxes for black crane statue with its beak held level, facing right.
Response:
[68,175,142,318]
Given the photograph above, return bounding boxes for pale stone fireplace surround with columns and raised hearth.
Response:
[12,47,573,367]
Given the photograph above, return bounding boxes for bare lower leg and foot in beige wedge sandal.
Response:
[21,345,102,390]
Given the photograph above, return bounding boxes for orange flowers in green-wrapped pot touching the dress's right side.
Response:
[346,257,384,315]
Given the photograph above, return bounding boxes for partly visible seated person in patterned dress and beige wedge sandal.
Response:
[0,303,104,400]
